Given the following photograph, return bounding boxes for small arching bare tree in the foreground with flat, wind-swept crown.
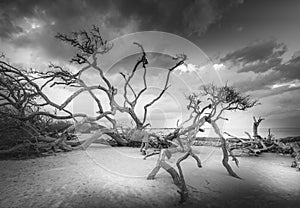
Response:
[148,84,257,202]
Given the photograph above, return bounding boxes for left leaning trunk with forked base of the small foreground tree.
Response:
[147,94,211,203]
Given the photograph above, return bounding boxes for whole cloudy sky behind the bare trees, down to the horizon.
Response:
[0,0,300,136]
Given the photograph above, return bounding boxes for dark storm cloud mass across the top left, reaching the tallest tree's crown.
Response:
[0,0,242,63]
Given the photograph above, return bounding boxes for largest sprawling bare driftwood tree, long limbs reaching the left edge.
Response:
[0,26,186,154]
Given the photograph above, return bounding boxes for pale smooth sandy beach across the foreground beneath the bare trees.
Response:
[0,144,300,208]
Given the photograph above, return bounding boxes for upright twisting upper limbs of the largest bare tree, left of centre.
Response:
[51,27,186,141]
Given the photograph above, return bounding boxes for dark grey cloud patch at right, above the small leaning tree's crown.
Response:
[220,40,300,81]
